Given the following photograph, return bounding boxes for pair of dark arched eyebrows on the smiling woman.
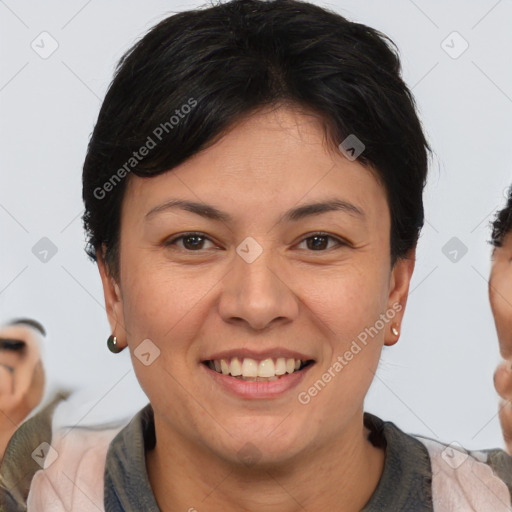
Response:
[146,198,365,223]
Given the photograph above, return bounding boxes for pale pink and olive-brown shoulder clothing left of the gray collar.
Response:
[0,393,138,512]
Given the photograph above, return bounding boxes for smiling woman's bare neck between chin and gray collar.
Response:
[146,411,385,512]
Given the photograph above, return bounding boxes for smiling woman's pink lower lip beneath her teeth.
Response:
[201,363,314,399]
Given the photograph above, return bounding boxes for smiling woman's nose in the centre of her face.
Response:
[219,245,300,330]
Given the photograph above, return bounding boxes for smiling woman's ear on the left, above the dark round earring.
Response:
[96,245,127,348]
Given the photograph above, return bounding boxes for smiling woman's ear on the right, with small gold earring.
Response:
[384,247,416,346]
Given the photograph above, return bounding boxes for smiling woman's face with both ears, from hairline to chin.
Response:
[100,108,413,463]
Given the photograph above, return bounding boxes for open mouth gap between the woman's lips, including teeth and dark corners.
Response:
[203,357,315,382]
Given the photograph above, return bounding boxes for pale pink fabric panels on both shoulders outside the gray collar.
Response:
[28,428,512,512]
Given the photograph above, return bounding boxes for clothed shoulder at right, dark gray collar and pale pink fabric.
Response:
[365,413,512,512]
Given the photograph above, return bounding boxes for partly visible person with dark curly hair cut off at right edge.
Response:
[489,187,512,455]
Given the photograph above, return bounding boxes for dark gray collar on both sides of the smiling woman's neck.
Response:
[105,404,433,512]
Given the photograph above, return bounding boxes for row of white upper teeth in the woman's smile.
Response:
[208,357,302,377]
